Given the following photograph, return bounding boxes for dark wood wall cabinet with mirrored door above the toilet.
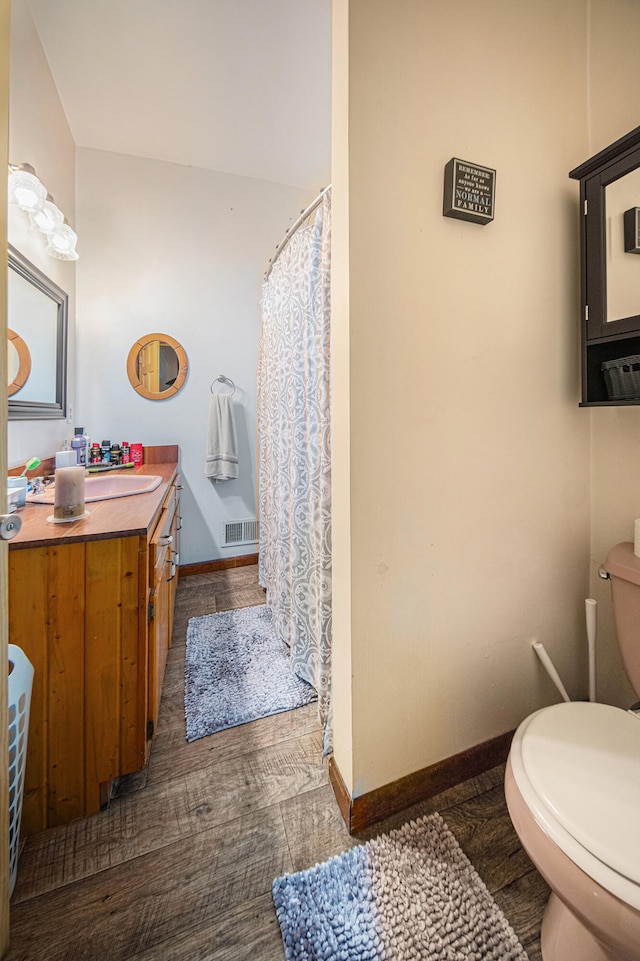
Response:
[569,127,640,407]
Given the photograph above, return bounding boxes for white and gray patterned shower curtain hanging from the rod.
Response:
[258,191,332,757]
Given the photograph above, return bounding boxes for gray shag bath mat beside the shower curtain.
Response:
[184,604,317,741]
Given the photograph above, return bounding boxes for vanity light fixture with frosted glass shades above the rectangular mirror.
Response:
[9,164,78,260]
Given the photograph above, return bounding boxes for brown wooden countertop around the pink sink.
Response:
[9,461,178,550]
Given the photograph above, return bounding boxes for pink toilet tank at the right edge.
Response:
[604,543,640,696]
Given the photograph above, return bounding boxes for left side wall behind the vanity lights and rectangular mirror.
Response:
[7,0,75,467]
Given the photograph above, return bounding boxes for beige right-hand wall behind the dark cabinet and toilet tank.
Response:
[584,0,640,707]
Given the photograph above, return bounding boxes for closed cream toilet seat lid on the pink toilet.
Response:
[511,701,640,910]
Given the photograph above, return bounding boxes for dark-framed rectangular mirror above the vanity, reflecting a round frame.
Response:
[7,244,69,420]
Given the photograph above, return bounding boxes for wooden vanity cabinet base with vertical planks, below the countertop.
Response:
[9,471,179,834]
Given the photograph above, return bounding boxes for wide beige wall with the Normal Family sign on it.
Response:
[333,0,604,796]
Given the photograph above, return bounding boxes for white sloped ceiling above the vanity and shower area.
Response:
[28,0,331,190]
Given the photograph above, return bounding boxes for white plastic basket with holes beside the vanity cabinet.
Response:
[8,644,33,896]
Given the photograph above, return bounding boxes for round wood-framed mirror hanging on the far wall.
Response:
[127,334,189,400]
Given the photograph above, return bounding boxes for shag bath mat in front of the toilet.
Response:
[273,814,527,961]
